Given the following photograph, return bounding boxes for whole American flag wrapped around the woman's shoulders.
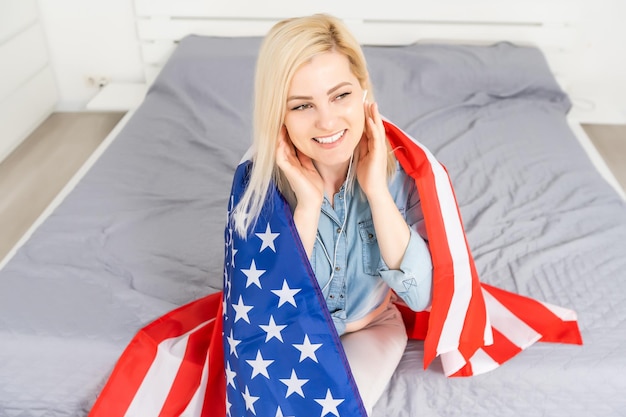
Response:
[90,121,582,417]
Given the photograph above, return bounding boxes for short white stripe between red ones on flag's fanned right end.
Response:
[483,290,541,349]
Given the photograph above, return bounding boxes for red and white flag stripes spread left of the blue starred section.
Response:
[89,293,223,417]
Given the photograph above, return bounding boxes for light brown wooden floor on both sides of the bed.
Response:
[0,112,626,260]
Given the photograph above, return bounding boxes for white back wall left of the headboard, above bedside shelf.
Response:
[38,0,143,111]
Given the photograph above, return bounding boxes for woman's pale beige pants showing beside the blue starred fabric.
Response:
[341,303,407,415]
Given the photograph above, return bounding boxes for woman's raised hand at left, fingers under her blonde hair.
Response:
[276,126,324,210]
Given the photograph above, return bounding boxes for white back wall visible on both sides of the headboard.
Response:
[38,0,626,118]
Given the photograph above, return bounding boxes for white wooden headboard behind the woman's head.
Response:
[135,0,582,88]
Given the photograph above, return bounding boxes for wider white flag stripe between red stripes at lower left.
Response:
[124,318,215,417]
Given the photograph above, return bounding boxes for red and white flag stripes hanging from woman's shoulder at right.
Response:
[385,122,492,374]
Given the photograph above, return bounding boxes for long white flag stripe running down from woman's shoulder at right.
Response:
[390,122,478,354]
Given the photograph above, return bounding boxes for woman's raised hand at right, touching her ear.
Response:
[356,101,387,200]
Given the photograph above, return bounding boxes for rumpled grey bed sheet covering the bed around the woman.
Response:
[0,36,626,417]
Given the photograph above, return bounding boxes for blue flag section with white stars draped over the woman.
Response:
[223,162,366,417]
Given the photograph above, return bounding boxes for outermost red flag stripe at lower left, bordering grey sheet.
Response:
[89,292,222,417]
